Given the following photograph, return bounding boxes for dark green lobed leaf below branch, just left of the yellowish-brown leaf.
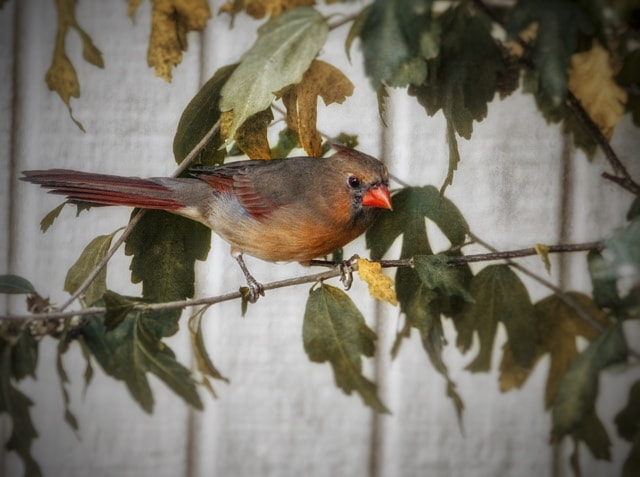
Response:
[455,265,538,372]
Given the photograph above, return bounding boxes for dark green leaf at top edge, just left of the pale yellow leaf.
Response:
[506,0,594,100]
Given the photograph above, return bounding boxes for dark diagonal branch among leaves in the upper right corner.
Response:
[473,0,640,196]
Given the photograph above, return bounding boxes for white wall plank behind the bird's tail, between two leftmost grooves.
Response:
[5,0,199,476]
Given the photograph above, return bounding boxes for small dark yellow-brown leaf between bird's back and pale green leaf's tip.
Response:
[220,107,273,159]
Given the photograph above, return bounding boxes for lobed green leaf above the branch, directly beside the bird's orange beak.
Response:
[366,186,469,260]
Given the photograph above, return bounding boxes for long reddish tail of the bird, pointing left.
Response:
[21,169,184,210]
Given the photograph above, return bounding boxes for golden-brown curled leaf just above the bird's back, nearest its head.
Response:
[282,60,353,157]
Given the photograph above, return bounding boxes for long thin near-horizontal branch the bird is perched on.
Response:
[0,238,602,320]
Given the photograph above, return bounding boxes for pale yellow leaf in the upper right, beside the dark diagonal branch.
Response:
[569,42,627,139]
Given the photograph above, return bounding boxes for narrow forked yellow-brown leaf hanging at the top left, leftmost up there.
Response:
[45,0,104,132]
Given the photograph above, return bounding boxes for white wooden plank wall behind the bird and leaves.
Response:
[0,0,640,477]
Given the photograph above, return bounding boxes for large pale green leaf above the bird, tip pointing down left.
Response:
[220,7,329,143]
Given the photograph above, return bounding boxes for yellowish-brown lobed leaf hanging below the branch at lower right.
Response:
[500,292,609,409]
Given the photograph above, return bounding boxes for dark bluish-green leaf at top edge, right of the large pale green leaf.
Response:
[358,0,432,90]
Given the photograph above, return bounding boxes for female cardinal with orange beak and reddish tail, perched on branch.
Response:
[22,146,391,301]
